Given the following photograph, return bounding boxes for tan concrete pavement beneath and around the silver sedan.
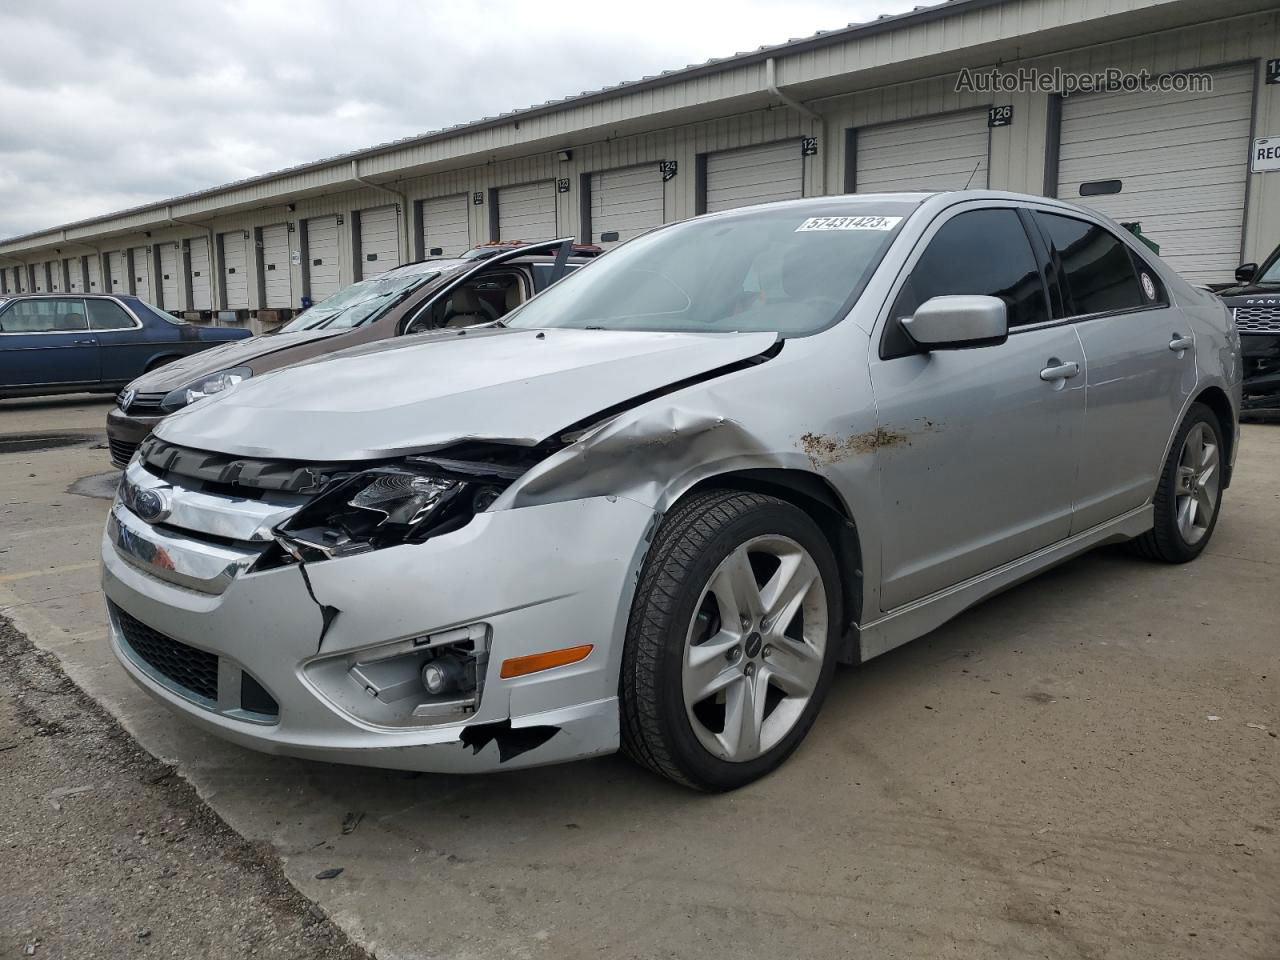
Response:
[0,399,1280,960]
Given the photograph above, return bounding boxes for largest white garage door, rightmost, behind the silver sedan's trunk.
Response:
[1057,67,1253,283]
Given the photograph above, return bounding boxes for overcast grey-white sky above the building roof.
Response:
[0,0,919,238]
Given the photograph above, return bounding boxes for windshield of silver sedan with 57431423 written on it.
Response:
[506,201,915,337]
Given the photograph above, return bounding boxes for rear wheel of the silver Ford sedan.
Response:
[1133,403,1226,563]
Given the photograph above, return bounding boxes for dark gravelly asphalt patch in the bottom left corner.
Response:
[0,618,369,960]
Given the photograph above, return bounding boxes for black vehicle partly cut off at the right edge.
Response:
[1217,247,1280,410]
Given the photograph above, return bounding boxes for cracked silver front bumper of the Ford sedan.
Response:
[102,497,655,773]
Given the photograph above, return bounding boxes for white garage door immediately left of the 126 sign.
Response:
[854,110,991,193]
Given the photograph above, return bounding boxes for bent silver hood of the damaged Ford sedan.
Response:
[156,328,777,461]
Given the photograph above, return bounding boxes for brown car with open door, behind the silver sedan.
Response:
[106,239,600,468]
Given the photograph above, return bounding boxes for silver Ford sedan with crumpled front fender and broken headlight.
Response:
[102,191,1240,790]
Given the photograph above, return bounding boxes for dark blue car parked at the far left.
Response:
[0,293,251,397]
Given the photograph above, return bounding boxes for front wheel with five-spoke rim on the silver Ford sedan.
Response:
[620,490,841,791]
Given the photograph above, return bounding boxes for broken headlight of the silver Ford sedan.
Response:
[275,465,500,561]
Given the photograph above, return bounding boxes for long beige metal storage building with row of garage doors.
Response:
[0,0,1280,321]
